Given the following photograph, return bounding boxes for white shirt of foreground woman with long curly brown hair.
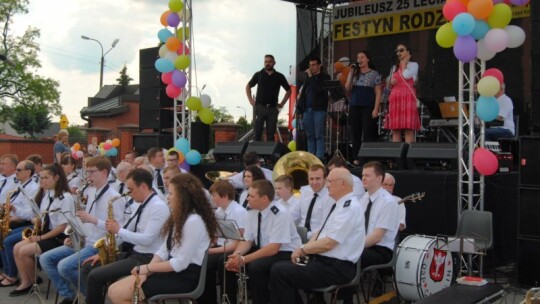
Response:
[156,214,210,272]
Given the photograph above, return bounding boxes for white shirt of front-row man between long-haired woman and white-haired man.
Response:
[244,202,302,251]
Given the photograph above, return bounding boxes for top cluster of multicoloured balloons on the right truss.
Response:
[435,0,530,63]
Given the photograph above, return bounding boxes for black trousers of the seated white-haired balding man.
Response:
[270,255,356,304]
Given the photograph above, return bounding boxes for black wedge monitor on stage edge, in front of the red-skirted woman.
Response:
[358,142,409,170]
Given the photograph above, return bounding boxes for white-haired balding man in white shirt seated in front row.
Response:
[270,168,365,304]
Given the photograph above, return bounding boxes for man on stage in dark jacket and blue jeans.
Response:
[296,57,330,159]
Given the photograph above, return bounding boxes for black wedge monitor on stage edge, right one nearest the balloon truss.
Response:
[407,143,459,170]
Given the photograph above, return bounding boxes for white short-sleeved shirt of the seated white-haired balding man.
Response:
[318,193,365,263]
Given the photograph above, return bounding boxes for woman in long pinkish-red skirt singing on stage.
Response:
[385,44,420,143]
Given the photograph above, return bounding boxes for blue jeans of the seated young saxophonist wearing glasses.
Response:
[39,246,98,299]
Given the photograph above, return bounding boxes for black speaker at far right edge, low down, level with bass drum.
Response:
[517,238,540,286]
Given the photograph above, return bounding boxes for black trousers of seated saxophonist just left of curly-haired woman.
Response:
[81,252,154,304]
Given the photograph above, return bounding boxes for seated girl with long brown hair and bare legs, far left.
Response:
[9,164,75,296]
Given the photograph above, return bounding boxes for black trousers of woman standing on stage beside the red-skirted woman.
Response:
[349,106,378,159]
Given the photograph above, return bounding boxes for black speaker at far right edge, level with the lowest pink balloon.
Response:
[519,137,540,187]
